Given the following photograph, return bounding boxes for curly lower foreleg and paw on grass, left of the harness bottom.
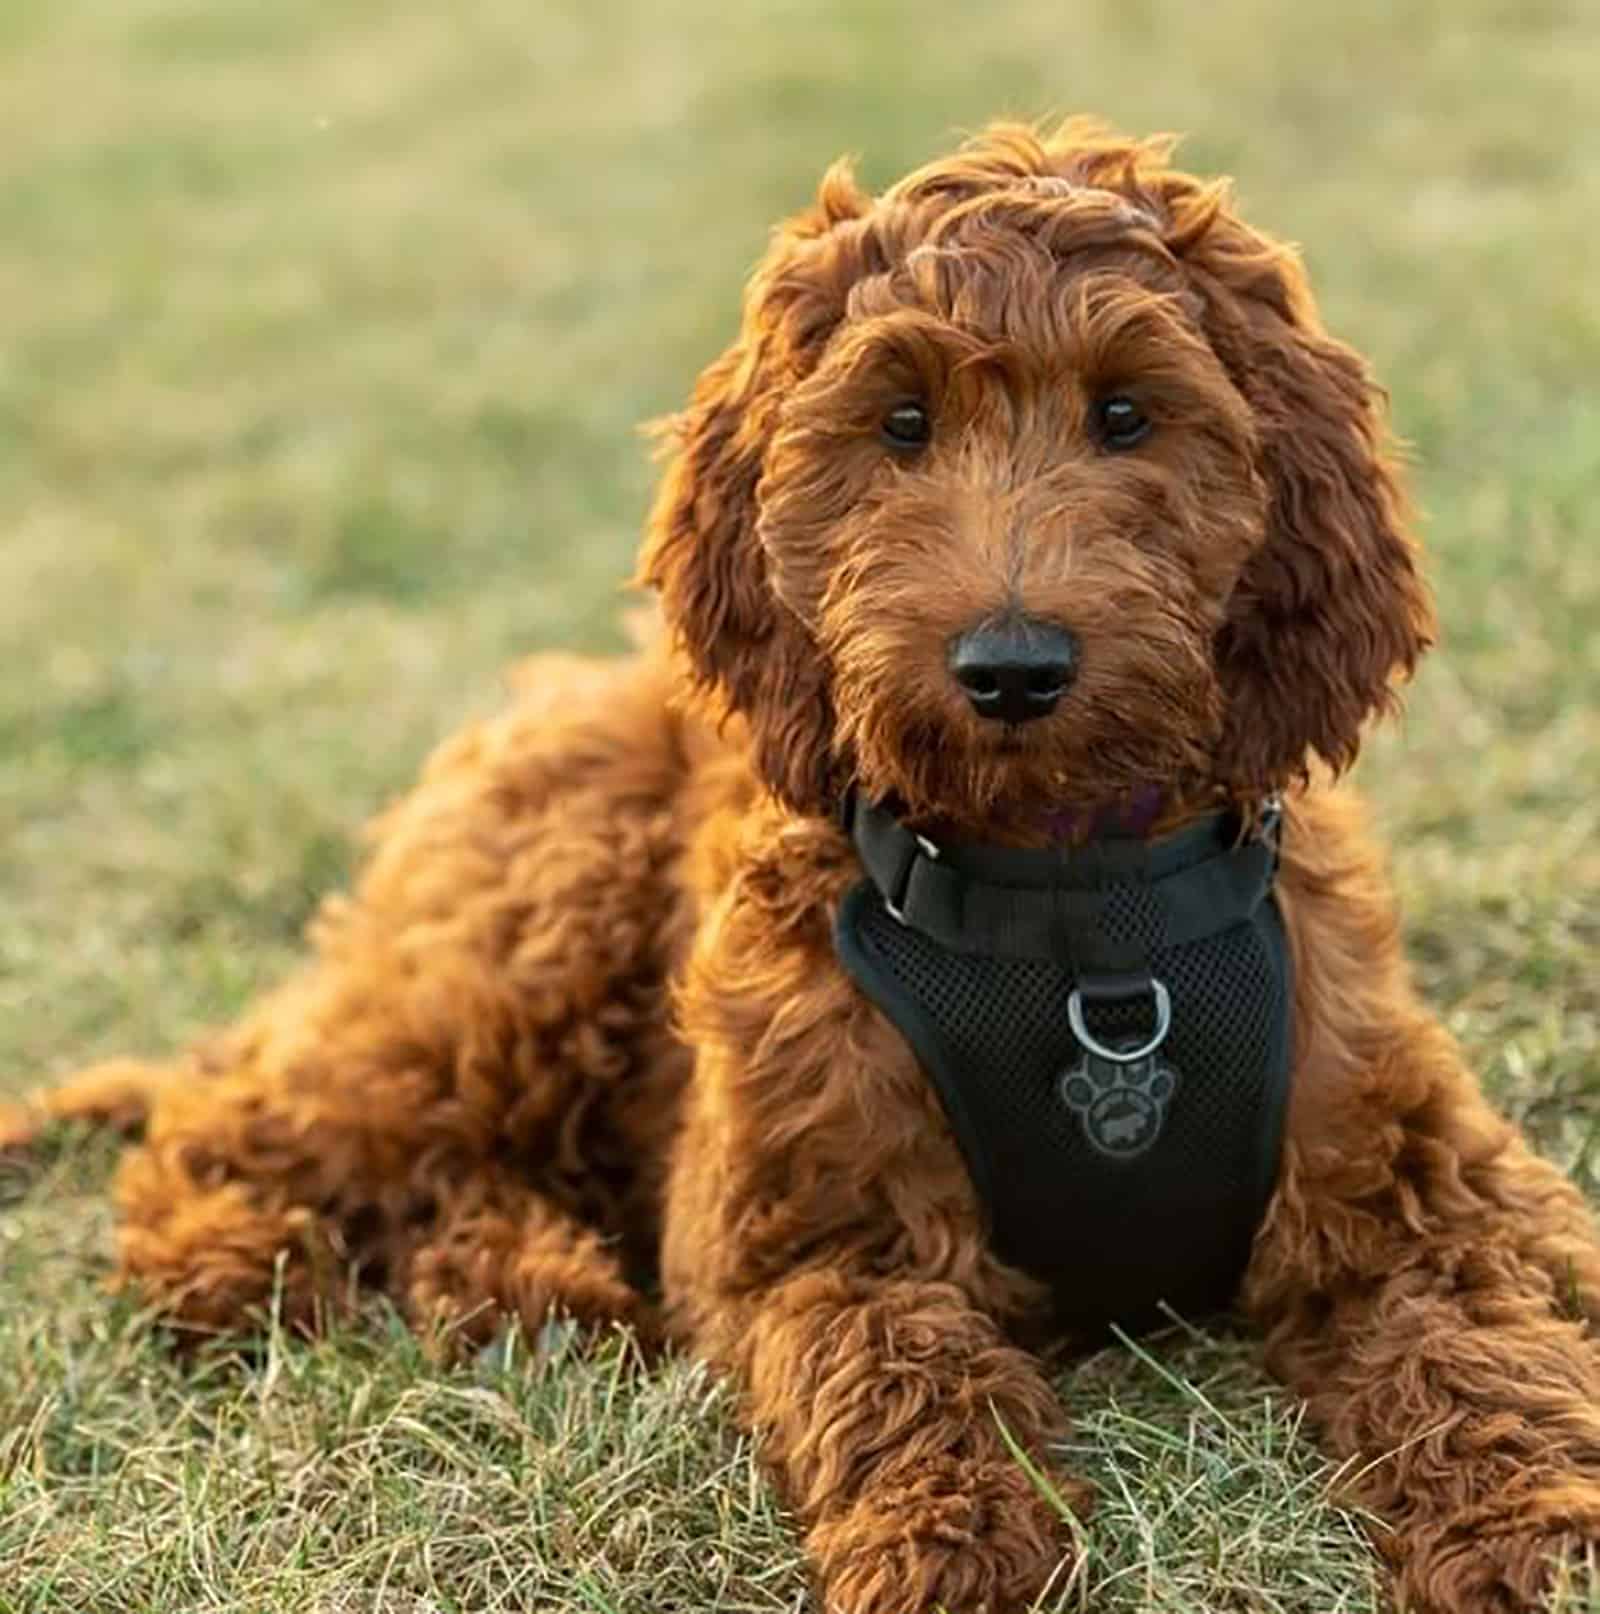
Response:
[728,1267,1064,1614]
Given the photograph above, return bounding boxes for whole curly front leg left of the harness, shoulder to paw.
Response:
[664,852,1080,1614]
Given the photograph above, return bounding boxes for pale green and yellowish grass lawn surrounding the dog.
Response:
[0,0,1600,1614]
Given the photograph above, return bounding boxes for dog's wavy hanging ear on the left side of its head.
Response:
[636,163,870,812]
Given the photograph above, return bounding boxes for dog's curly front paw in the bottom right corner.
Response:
[1395,1485,1600,1614]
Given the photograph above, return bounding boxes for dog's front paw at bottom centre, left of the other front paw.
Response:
[810,1461,1088,1614]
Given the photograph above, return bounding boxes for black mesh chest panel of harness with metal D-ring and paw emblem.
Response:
[836,852,1292,1328]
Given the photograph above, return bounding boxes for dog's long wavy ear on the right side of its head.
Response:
[1167,187,1434,791]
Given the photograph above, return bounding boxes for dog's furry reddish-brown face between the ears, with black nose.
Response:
[756,184,1267,820]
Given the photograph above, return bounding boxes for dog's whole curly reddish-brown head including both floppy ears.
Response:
[641,123,1430,828]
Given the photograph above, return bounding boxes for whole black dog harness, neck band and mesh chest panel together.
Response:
[835,799,1293,1327]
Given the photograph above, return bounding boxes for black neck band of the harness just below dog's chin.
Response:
[843,792,1279,975]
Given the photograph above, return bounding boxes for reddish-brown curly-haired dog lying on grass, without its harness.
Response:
[8,123,1600,1614]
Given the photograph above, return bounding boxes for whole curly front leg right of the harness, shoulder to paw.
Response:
[1245,807,1600,1614]
